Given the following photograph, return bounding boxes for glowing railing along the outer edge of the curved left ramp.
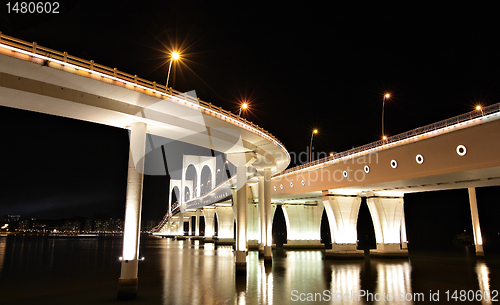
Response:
[0,32,290,158]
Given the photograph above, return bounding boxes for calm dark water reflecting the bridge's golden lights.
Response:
[0,237,500,305]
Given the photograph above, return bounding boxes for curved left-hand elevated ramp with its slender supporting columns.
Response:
[0,33,290,299]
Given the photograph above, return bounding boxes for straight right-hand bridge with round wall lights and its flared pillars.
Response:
[155,104,500,257]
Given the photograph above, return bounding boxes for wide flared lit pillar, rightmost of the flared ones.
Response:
[366,197,408,258]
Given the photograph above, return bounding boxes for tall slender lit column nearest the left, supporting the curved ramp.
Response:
[117,122,146,300]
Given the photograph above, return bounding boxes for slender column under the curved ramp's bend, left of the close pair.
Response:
[236,164,248,273]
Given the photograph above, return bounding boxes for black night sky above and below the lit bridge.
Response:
[0,1,500,247]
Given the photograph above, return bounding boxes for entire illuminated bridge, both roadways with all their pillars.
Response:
[0,33,500,299]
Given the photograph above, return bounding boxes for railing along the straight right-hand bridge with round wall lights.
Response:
[275,103,500,177]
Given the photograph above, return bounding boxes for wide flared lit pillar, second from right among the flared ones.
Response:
[323,195,365,258]
